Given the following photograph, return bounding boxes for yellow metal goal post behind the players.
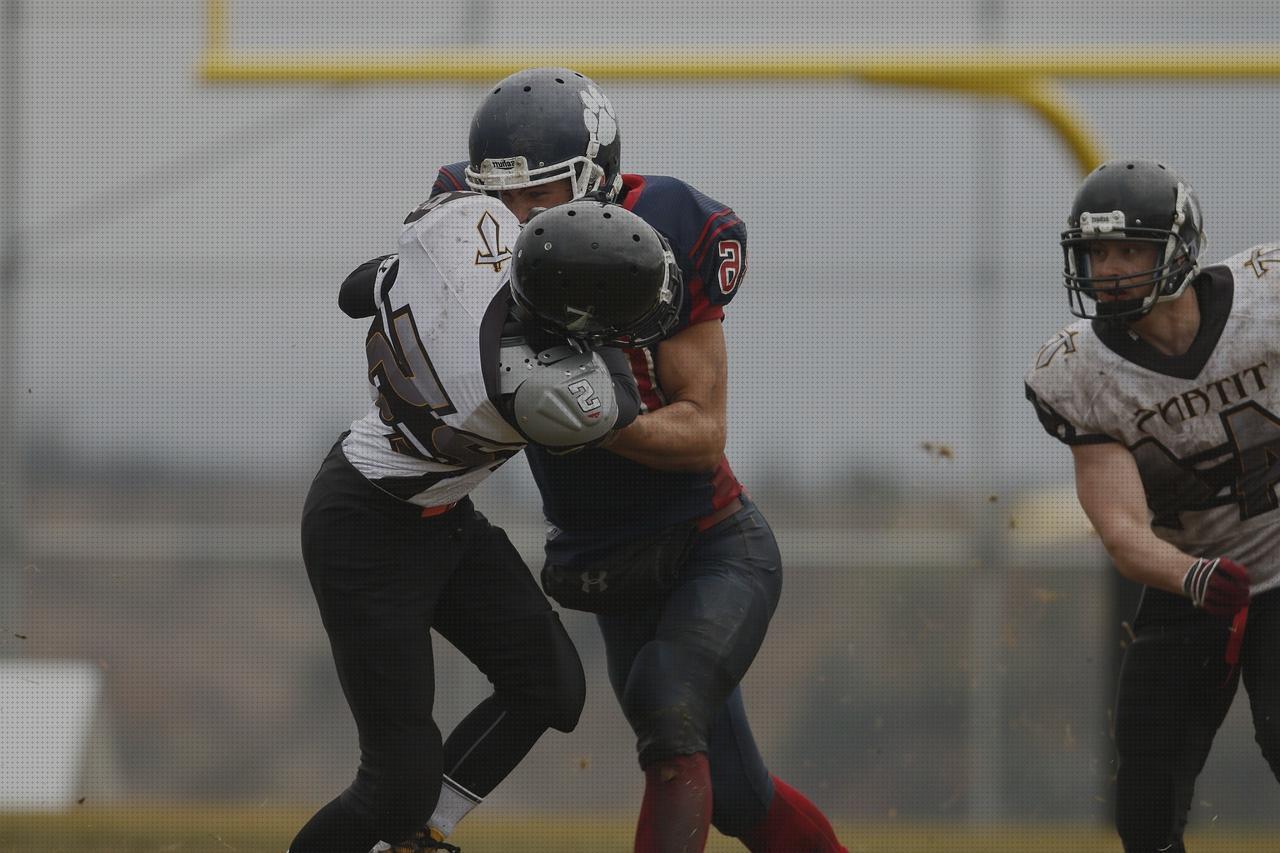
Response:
[200,0,1280,173]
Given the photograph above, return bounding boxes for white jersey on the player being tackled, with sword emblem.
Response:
[342,193,525,506]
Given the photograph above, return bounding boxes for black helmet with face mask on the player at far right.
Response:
[1061,160,1204,320]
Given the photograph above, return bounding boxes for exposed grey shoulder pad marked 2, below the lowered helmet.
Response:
[498,338,618,447]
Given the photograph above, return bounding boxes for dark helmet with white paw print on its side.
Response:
[466,68,622,201]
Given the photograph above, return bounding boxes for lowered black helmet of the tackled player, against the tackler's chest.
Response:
[511,199,685,347]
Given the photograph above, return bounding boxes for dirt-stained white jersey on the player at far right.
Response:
[1027,245,1280,594]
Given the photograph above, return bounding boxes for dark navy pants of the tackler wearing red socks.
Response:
[598,497,782,838]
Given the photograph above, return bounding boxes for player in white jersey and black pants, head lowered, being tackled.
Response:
[291,192,680,853]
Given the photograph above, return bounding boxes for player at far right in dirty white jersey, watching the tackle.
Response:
[1027,160,1280,853]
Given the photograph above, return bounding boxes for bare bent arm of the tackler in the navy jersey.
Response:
[605,317,728,471]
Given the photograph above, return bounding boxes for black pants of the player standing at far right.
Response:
[1116,588,1280,853]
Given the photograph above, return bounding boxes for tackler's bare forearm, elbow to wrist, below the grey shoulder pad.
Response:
[604,401,726,471]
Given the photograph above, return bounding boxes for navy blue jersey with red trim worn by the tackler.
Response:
[431,163,746,558]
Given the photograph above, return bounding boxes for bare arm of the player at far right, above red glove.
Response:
[1071,435,1196,596]
